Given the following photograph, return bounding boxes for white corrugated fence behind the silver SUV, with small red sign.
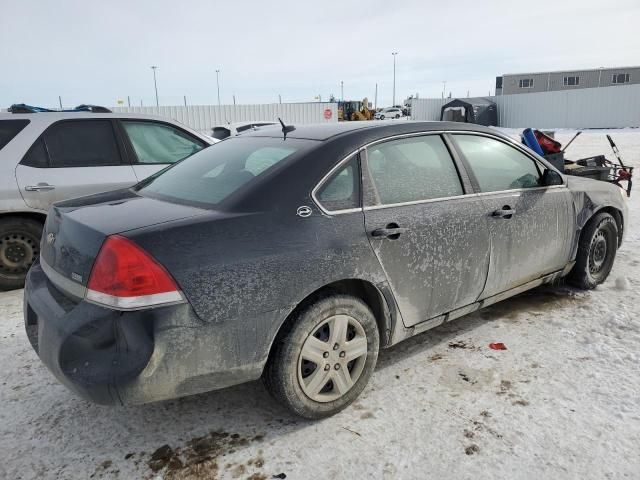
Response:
[112,102,338,133]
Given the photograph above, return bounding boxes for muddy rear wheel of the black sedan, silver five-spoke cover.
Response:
[263,295,380,419]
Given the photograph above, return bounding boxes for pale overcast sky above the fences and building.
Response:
[0,0,640,108]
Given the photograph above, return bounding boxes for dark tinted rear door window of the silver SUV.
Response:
[42,120,120,167]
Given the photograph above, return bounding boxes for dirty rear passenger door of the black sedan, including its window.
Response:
[363,134,489,326]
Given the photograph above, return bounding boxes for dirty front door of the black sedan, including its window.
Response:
[452,133,576,298]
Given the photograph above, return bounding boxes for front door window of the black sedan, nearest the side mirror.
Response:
[453,135,540,192]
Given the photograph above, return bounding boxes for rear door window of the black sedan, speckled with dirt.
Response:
[367,135,463,205]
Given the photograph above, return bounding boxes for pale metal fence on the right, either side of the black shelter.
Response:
[411,85,640,128]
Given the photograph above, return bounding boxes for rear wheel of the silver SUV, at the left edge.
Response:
[0,217,42,290]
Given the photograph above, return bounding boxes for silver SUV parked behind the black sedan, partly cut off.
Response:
[0,112,217,290]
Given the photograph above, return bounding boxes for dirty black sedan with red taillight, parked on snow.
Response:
[24,122,627,418]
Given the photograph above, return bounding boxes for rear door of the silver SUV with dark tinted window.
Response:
[16,118,136,211]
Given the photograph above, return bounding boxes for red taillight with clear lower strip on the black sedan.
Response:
[86,235,184,310]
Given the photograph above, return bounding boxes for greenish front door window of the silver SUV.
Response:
[122,120,205,164]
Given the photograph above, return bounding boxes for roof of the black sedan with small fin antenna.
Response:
[243,121,500,141]
